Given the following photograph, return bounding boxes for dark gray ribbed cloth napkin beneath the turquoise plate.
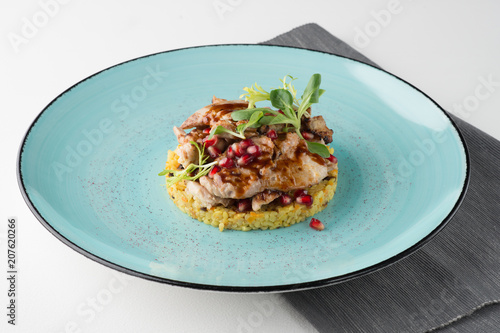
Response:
[264,24,500,333]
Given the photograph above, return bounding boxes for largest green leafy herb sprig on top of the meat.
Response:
[236,74,330,158]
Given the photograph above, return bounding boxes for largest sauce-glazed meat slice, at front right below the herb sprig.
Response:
[200,133,327,199]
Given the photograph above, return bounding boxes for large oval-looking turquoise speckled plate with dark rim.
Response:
[18,45,469,292]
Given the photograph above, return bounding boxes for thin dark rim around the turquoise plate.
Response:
[16,43,470,293]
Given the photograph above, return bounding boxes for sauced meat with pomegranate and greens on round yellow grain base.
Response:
[159,74,338,231]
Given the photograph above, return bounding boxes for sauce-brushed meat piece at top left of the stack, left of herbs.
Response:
[180,97,248,129]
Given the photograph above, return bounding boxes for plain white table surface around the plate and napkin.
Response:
[0,0,500,333]
